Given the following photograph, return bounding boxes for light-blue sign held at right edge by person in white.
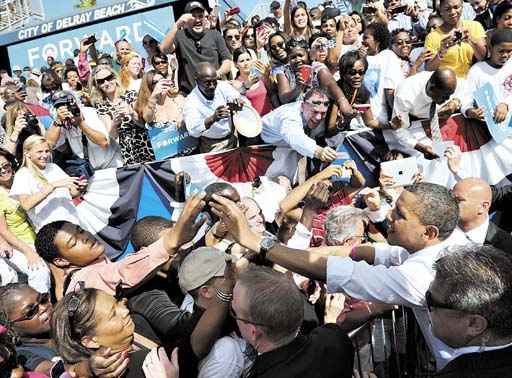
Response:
[474,83,512,144]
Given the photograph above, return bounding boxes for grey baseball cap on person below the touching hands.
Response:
[178,247,226,293]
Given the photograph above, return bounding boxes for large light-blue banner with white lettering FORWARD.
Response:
[7,7,174,68]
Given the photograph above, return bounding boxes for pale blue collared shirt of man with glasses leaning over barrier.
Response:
[261,101,325,158]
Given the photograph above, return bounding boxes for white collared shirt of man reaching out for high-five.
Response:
[327,234,468,370]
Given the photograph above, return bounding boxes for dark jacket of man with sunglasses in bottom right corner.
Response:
[435,346,512,378]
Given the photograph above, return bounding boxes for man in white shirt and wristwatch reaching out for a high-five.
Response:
[212,183,467,369]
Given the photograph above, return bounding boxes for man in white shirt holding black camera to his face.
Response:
[46,91,121,178]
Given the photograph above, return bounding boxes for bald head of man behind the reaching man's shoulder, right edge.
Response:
[452,177,492,227]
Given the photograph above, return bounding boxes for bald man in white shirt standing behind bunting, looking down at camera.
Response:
[183,62,241,153]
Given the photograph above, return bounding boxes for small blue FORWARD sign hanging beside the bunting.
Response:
[148,123,197,160]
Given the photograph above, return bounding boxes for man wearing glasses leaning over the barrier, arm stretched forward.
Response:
[261,87,336,162]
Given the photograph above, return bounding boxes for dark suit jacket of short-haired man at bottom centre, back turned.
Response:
[249,324,354,378]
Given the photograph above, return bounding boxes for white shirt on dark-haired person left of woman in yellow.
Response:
[364,49,405,123]
